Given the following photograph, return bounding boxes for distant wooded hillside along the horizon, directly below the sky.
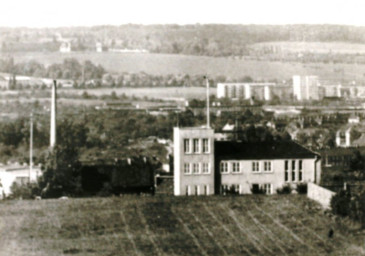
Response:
[0,24,365,56]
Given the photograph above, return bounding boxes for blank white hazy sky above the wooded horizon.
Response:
[0,0,365,27]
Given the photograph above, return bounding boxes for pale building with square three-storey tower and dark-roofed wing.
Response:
[174,127,321,196]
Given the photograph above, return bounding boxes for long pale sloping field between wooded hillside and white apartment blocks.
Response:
[7,52,365,80]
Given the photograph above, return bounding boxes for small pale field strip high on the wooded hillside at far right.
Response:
[252,41,365,54]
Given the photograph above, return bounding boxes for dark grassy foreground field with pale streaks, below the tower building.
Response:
[0,195,365,256]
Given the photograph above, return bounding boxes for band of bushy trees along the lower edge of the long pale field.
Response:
[0,58,253,89]
